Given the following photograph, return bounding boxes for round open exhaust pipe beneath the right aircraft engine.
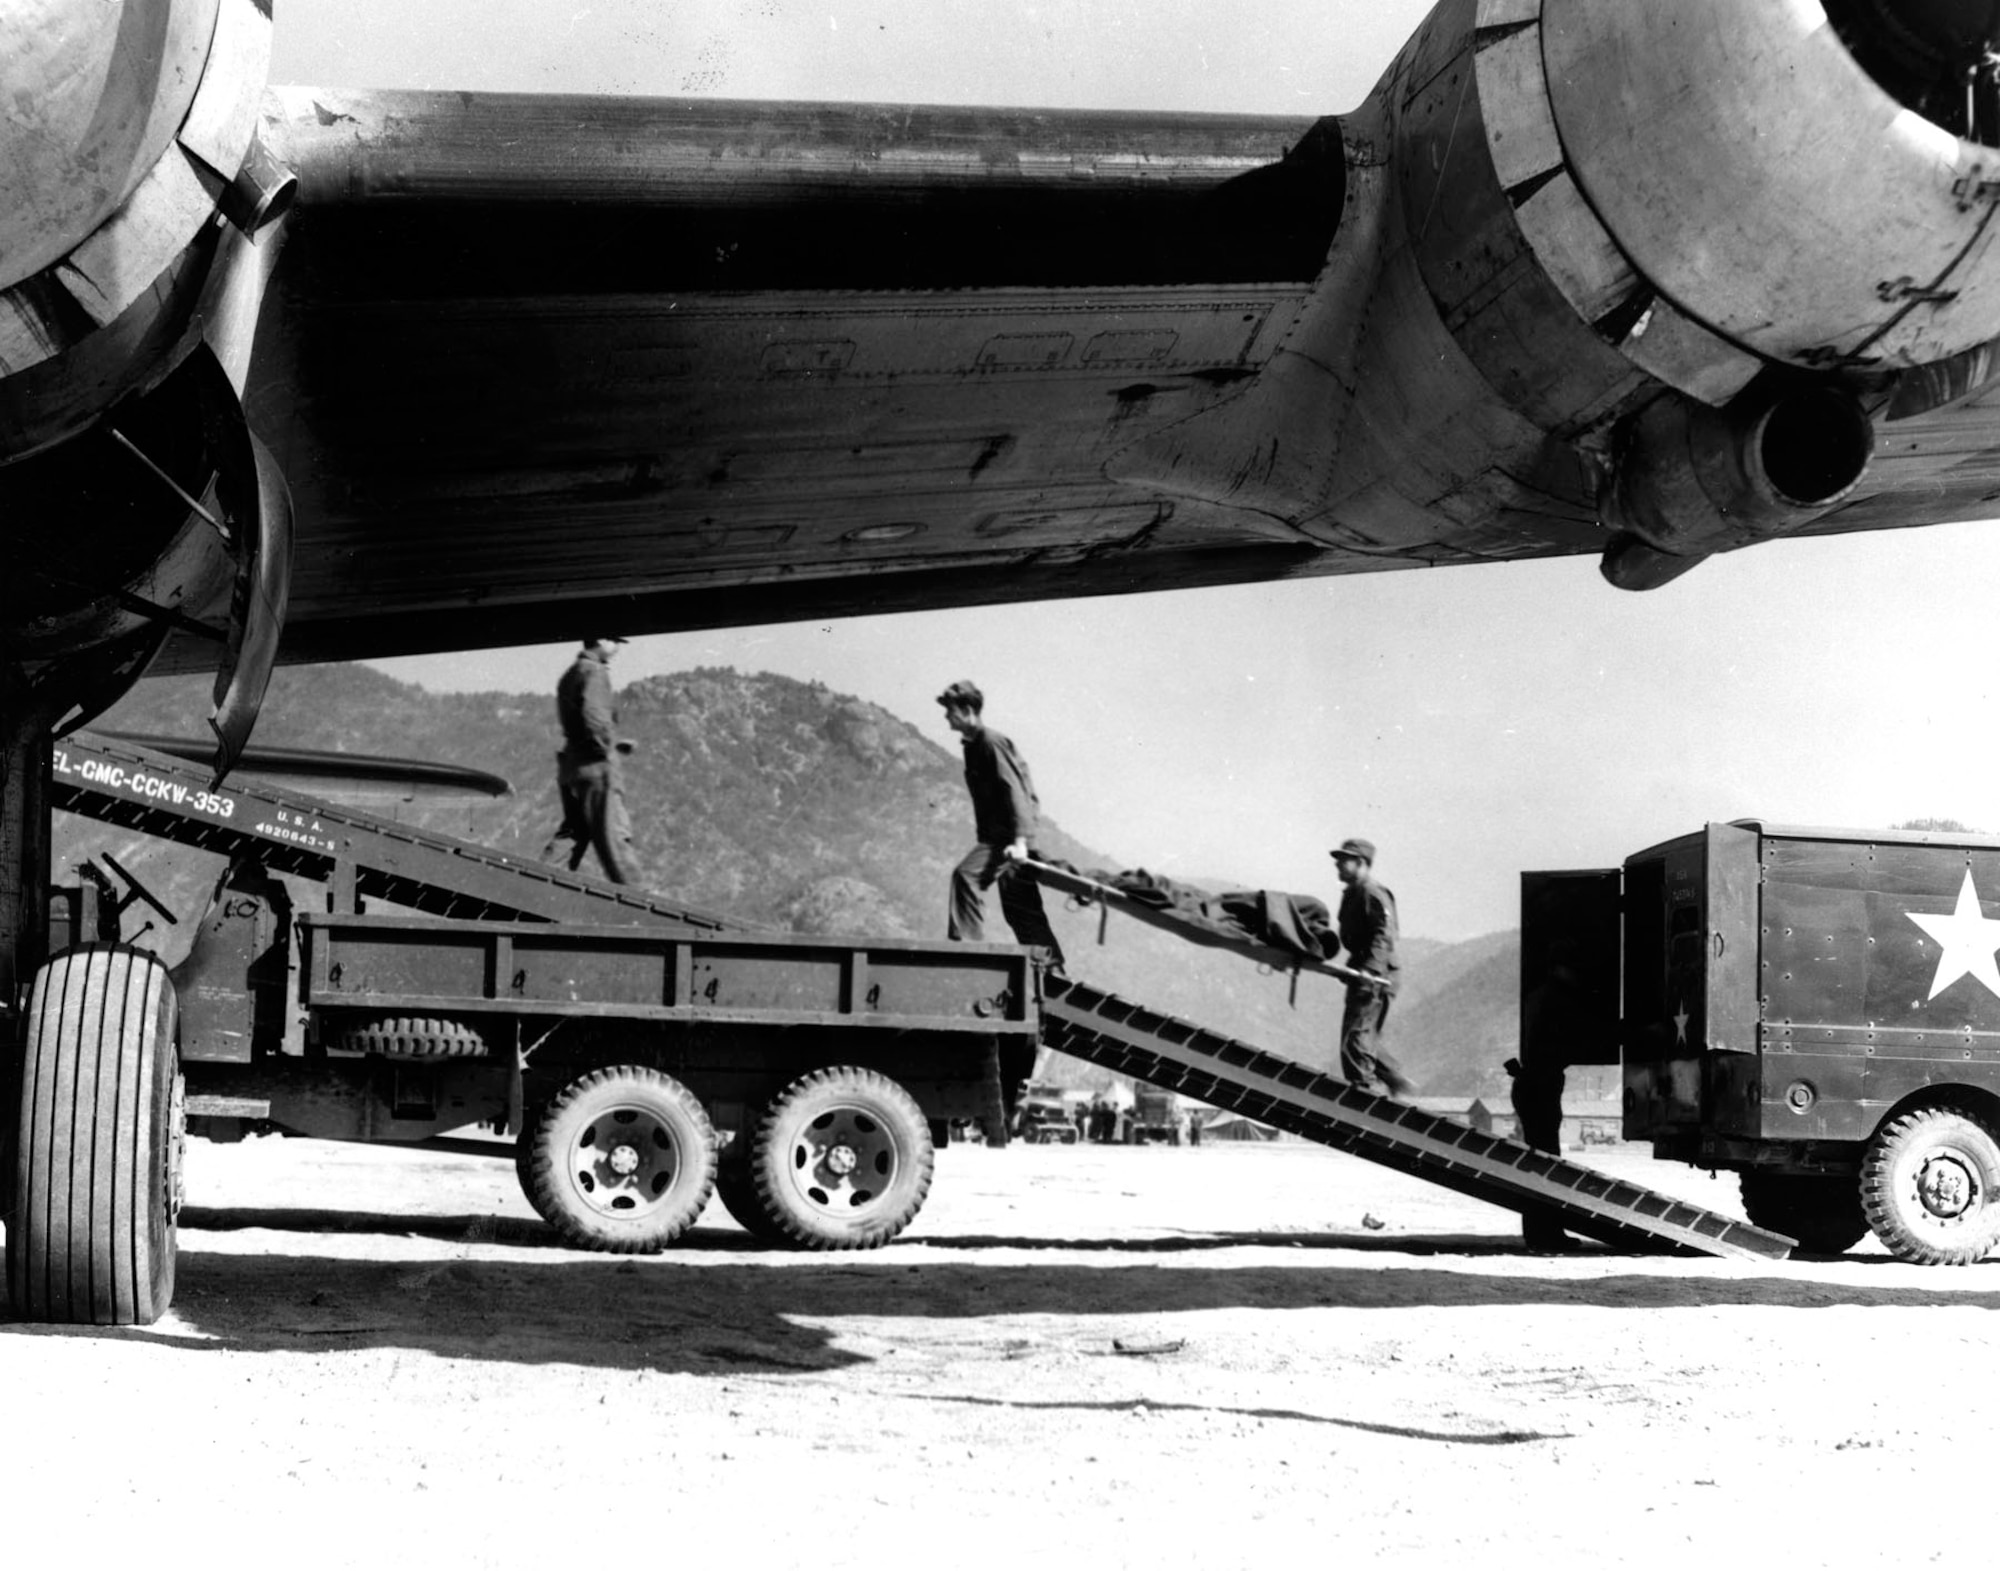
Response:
[1600,384,1874,590]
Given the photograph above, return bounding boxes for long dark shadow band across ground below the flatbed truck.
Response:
[0,1211,2000,1375]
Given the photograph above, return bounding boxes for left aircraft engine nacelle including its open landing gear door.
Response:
[0,0,296,772]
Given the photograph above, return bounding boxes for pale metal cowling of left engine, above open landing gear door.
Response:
[0,0,294,466]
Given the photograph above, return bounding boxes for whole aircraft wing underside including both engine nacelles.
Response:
[19,0,2000,687]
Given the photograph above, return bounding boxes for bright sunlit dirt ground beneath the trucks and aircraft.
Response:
[0,1139,2000,1571]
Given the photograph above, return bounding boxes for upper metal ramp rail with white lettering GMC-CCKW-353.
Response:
[50,732,760,933]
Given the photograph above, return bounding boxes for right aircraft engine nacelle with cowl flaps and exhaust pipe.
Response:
[1356,0,2000,588]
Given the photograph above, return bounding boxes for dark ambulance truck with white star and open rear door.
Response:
[1522,819,2000,1265]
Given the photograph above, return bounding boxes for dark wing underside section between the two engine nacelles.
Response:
[246,94,1594,660]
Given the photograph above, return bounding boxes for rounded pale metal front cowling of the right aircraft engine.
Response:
[1538,0,2000,370]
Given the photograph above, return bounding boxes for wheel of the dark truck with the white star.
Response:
[1862,1107,2000,1265]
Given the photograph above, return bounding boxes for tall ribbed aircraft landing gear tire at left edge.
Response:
[6,945,186,1325]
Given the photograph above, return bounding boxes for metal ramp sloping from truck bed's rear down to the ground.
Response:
[1042,975,1794,1259]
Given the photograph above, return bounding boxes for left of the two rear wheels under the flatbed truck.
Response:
[528,1065,716,1255]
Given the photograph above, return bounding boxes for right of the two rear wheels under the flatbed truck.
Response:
[750,1067,934,1249]
